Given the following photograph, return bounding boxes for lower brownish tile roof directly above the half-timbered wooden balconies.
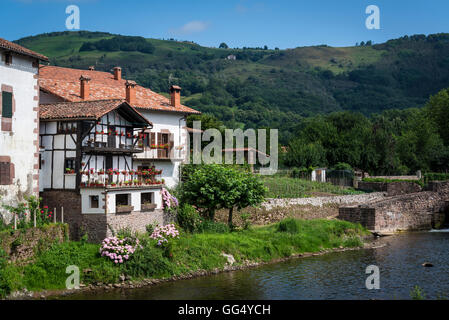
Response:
[39,99,151,125]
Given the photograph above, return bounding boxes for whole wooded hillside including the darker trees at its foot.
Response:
[17,31,449,173]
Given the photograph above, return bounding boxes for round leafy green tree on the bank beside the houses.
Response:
[181,164,266,226]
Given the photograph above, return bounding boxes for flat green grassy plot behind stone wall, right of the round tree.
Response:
[263,176,363,198]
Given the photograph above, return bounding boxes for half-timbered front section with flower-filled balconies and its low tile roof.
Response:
[40,100,168,240]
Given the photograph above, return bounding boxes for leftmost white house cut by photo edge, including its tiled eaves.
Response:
[0,38,48,220]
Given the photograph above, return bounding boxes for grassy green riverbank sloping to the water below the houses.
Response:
[2,219,369,299]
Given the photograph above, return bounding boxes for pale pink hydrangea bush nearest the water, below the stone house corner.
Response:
[100,237,142,264]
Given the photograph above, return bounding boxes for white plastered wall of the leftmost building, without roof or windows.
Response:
[0,51,39,220]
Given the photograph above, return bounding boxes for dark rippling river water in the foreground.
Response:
[60,230,449,300]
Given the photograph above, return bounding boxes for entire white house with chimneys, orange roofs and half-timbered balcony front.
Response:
[39,66,199,240]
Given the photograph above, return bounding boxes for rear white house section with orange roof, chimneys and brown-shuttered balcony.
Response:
[39,66,200,187]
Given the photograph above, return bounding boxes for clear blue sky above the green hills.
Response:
[0,0,449,49]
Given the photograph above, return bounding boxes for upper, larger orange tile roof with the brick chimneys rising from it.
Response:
[39,66,200,113]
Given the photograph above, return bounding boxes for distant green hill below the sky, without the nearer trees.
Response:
[17,31,449,142]
